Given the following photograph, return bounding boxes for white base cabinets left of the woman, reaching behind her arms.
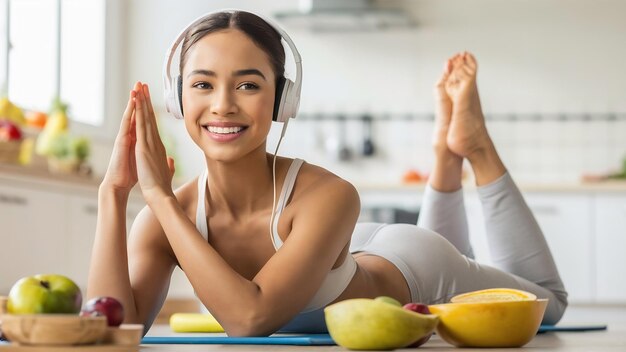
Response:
[0,175,144,295]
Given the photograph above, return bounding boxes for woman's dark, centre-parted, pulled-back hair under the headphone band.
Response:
[179,11,285,80]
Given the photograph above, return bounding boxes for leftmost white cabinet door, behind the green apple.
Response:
[0,184,67,294]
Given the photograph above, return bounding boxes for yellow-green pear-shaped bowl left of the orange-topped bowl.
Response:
[324,298,439,350]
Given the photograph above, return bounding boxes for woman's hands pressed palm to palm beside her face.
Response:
[101,82,174,205]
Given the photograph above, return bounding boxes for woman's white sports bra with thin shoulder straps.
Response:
[196,159,356,314]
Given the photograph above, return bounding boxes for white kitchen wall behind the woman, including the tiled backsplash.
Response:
[97,0,626,182]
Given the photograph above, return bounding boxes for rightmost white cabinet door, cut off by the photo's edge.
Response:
[595,194,626,304]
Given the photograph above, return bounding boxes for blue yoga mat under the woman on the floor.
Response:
[141,324,607,346]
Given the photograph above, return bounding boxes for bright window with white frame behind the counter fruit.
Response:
[0,0,106,127]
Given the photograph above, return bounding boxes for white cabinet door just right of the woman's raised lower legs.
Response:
[525,193,595,302]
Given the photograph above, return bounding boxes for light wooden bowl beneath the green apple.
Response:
[0,314,107,346]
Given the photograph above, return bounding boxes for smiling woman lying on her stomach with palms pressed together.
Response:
[87,11,567,336]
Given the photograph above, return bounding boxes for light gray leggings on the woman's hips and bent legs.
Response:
[350,173,567,324]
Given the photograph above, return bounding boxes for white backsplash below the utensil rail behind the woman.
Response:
[258,114,626,184]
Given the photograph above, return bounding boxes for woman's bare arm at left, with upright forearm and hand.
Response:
[86,85,174,336]
